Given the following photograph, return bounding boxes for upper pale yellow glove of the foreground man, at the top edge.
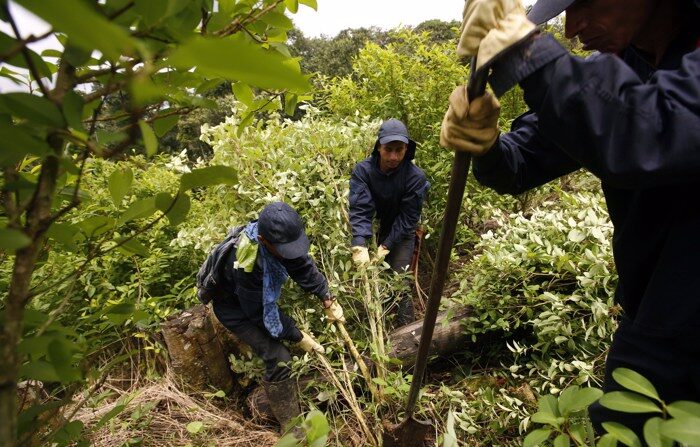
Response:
[457,0,537,70]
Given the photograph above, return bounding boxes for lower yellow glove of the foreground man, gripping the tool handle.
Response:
[440,86,501,156]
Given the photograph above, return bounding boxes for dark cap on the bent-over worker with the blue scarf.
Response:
[258,202,310,259]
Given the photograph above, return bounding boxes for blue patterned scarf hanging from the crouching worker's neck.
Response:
[244,221,288,338]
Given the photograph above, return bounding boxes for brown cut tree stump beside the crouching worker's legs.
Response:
[163,304,250,394]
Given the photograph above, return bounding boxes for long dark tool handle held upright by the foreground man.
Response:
[406,57,487,419]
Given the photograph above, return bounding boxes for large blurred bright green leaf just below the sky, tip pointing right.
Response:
[168,34,311,92]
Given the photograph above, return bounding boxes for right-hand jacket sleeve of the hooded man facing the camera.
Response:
[381,171,430,250]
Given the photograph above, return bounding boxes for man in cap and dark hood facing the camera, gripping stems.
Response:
[350,118,430,326]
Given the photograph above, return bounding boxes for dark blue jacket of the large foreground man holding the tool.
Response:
[474,22,700,336]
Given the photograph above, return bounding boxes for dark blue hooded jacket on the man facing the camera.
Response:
[350,140,430,250]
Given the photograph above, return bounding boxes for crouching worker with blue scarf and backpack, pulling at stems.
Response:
[198,202,345,430]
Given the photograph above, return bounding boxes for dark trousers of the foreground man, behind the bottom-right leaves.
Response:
[588,319,700,441]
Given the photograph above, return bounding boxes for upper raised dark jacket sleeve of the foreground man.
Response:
[496,36,700,189]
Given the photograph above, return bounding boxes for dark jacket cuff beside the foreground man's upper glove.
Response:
[489,34,567,97]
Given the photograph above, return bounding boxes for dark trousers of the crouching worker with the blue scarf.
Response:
[212,298,292,382]
